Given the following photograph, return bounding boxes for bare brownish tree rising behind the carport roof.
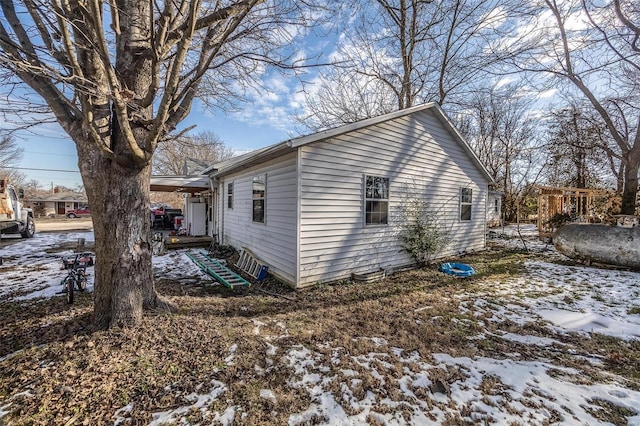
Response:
[153,131,234,175]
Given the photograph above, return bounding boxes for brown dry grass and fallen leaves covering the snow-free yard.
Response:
[0,248,640,425]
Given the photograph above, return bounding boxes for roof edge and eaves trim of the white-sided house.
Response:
[210,102,493,182]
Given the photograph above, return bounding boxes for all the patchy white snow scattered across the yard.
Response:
[0,227,640,425]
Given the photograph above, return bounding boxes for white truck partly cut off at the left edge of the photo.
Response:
[0,179,36,238]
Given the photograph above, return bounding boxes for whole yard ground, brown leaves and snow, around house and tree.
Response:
[0,226,640,426]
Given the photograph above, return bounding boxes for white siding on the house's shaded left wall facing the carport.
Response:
[221,153,297,283]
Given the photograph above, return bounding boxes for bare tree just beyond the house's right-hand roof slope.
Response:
[458,85,544,220]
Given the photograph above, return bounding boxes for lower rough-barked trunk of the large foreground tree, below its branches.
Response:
[78,138,159,328]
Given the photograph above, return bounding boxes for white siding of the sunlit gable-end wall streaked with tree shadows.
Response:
[298,110,487,286]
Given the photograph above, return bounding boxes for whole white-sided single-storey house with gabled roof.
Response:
[208,104,491,287]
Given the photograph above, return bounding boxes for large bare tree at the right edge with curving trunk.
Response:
[495,0,640,214]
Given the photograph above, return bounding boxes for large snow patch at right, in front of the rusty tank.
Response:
[470,255,640,340]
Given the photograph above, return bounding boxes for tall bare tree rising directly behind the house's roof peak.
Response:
[303,0,508,129]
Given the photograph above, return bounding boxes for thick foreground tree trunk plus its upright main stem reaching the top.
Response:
[78,0,158,327]
